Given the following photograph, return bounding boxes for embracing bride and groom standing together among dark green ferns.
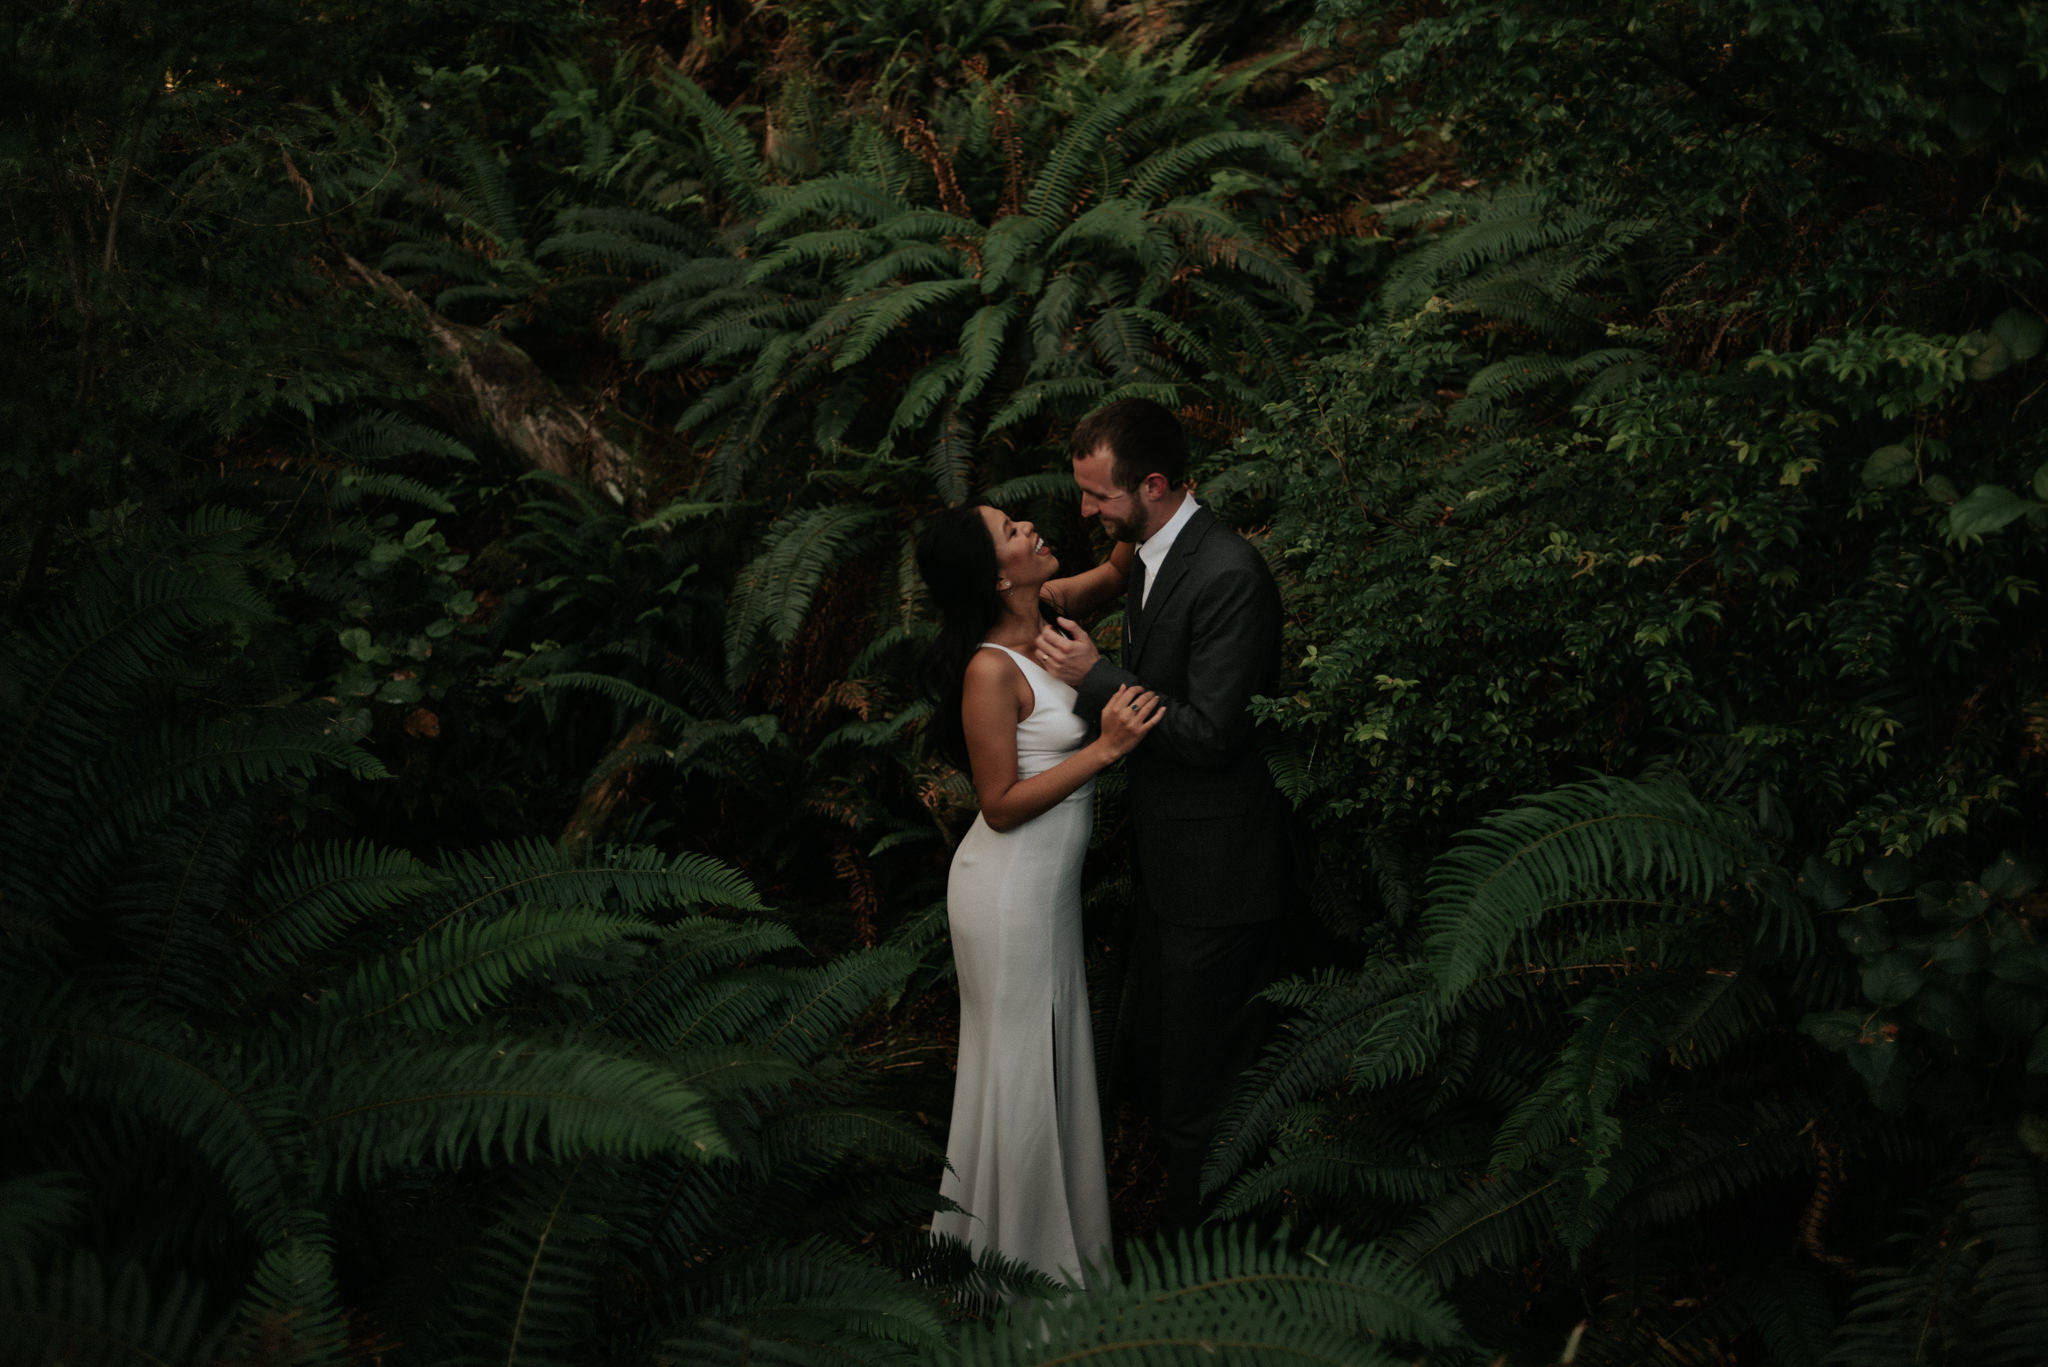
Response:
[918,400,1290,1285]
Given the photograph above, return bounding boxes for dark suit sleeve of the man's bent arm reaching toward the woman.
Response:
[1075,564,1280,769]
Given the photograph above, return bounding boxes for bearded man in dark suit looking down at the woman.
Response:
[1034,400,1290,1230]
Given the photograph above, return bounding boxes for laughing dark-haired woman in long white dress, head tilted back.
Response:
[918,506,1165,1285]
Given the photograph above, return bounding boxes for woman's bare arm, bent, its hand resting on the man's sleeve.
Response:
[961,650,1165,830]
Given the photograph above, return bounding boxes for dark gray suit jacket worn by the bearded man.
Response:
[1073,508,1290,926]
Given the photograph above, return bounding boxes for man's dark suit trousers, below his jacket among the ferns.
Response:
[1116,910,1286,1230]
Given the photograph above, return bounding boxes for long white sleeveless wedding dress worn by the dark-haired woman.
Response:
[932,641,1110,1285]
